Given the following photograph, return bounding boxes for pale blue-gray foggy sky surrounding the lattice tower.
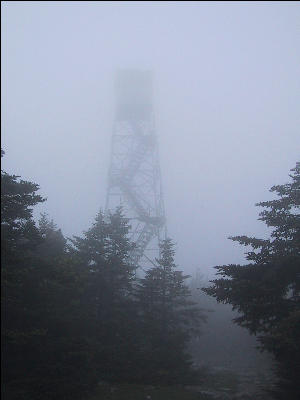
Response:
[1,1,300,274]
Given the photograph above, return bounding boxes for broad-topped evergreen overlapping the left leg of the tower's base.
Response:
[71,208,138,380]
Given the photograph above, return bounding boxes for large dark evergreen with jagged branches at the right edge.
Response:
[204,163,300,400]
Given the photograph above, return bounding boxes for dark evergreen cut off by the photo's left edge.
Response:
[1,151,44,396]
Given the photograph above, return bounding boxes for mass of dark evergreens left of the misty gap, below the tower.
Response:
[1,148,204,399]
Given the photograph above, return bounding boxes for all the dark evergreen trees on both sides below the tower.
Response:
[1,152,300,400]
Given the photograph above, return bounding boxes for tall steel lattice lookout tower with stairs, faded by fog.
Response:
[105,70,166,268]
